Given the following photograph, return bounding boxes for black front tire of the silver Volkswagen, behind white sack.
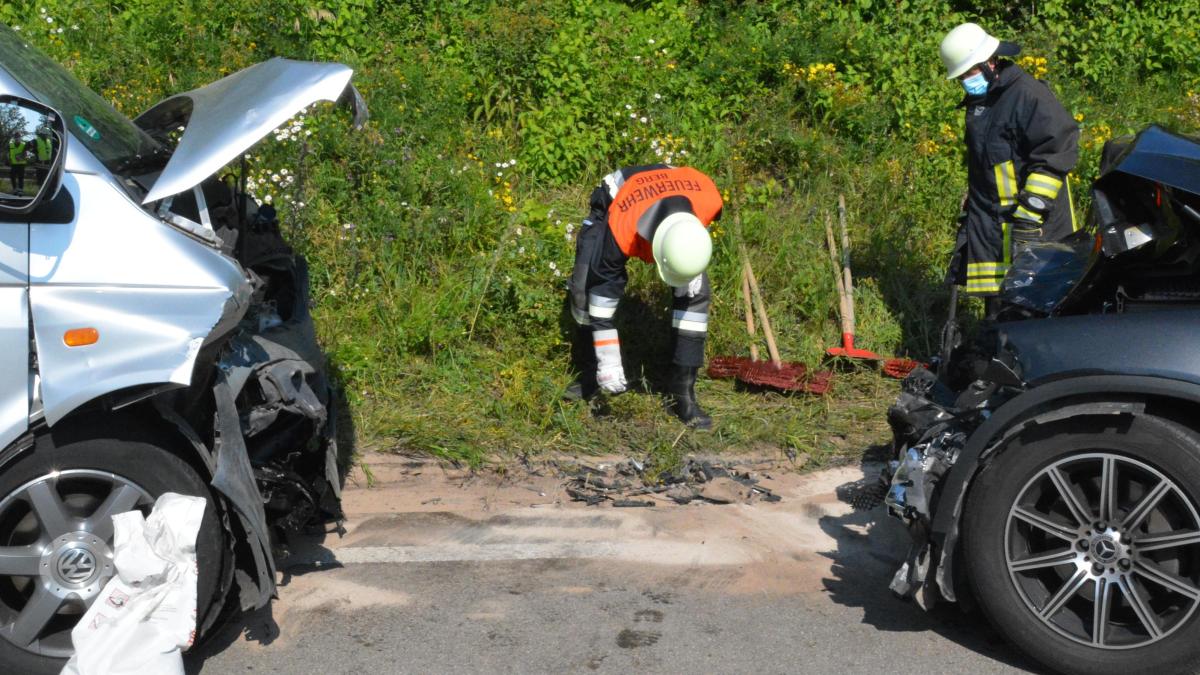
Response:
[0,434,227,674]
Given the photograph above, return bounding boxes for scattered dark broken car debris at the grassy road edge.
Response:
[564,459,780,507]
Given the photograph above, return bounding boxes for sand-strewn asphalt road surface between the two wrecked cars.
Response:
[187,459,1033,674]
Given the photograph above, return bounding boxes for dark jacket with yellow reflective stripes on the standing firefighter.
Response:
[952,61,1079,295]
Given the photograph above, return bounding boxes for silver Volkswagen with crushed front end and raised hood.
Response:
[0,26,366,673]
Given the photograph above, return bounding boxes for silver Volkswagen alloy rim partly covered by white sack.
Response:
[0,470,154,658]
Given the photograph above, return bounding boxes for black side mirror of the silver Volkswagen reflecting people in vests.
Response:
[0,95,67,215]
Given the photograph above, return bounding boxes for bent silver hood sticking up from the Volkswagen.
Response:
[133,58,366,204]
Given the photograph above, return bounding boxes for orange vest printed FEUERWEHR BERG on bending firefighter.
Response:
[608,167,722,263]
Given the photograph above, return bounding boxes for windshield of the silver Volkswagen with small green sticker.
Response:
[0,24,166,174]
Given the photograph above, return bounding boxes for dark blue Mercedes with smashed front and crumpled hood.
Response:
[886,126,1200,674]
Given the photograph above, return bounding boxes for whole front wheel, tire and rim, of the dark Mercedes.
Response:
[964,414,1200,674]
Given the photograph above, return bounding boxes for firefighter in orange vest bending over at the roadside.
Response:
[568,165,722,429]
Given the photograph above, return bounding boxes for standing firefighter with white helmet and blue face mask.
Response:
[941,23,1079,317]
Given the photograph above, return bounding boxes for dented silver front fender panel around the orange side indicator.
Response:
[29,174,250,425]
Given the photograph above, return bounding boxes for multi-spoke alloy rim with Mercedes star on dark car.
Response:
[1004,452,1200,650]
